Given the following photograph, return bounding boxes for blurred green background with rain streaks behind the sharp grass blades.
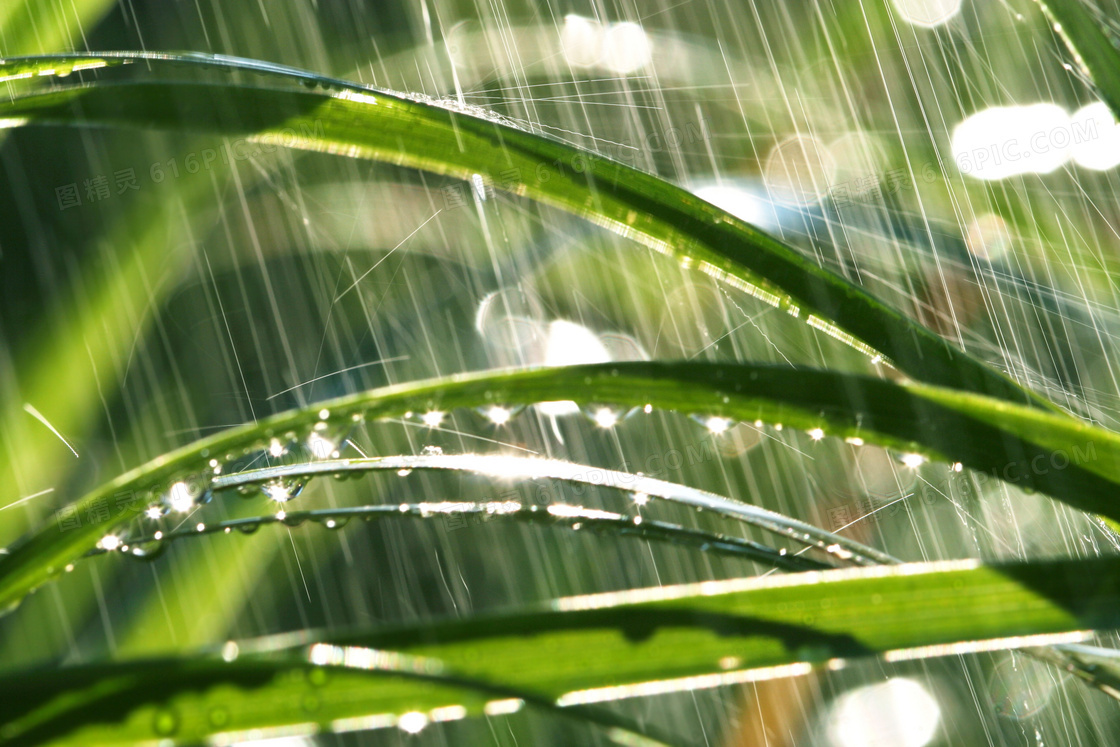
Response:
[0,0,1120,747]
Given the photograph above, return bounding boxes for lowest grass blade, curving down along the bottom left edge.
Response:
[0,652,680,747]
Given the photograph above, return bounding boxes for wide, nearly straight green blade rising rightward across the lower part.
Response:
[0,558,1120,745]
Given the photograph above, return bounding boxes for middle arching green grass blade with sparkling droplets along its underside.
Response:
[0,362,1120,607]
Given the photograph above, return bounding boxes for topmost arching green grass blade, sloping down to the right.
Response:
[0,53,1056,410]
